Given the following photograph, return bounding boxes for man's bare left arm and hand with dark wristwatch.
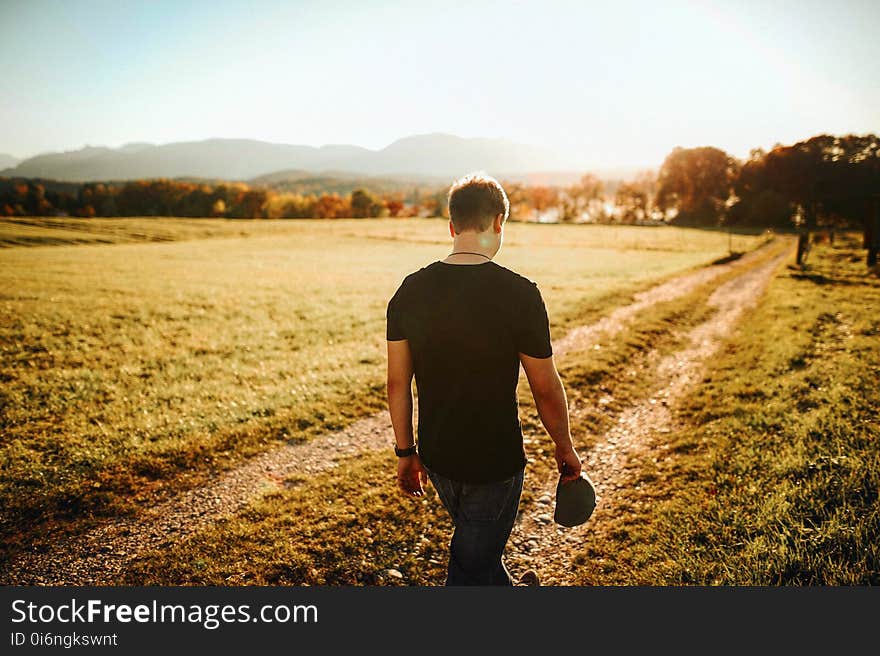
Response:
[387,339,428,497]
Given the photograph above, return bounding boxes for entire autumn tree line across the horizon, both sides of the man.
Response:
[0,134,880,239]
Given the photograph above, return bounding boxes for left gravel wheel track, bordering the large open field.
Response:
[0,238,780,585]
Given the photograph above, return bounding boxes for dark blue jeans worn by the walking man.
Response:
[428,470,525,585]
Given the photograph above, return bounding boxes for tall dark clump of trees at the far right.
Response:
[656,134,880,230]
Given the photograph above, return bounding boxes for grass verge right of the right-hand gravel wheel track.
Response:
[577,235,880,585]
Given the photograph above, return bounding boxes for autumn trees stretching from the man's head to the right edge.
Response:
[508,134,880,231]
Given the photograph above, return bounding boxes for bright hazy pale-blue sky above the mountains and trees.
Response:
[0,0,880,167]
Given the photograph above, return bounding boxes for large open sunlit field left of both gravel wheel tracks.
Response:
[0,219,762,553]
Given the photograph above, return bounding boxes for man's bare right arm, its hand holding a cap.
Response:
[519,353,581,480]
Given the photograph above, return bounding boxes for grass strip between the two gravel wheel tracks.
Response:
[125,240,776,585]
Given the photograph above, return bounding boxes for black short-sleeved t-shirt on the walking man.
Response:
[386,262,553,483]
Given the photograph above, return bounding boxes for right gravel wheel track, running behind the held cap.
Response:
[506,240,791,585]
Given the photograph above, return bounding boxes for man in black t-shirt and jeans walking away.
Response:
[386,174,581,585]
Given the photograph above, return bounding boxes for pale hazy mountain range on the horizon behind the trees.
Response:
[0,133,567,182]
